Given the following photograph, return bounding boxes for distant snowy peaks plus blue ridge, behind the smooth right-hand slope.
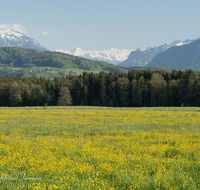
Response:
[56,38,199,67]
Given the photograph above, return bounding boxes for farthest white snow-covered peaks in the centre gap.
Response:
[56,47,133,65]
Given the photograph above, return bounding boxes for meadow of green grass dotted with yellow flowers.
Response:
[0,108,200,190]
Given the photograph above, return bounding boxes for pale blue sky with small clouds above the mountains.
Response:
[0,0,200,51]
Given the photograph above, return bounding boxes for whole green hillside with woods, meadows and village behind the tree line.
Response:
[0,47,185,79]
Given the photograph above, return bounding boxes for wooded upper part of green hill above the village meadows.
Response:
[0,47,126,72]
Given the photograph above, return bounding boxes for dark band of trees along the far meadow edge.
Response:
[0,70,200,107]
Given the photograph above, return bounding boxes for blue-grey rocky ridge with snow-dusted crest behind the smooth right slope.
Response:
[118,38,199,67]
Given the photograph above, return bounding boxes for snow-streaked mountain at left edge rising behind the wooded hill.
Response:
[0,28,48,51]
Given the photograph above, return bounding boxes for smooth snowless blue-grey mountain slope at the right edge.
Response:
[146,39,200,71]
